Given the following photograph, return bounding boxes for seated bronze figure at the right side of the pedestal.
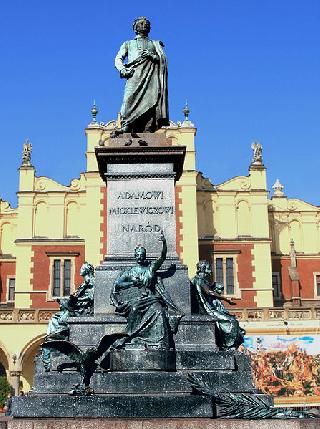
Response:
[191,261,245,350]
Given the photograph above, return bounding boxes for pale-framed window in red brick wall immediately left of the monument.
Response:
[51,258,73,298]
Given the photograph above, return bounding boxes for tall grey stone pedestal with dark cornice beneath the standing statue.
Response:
[94,133,190,315]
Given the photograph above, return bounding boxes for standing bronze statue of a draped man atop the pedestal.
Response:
[115,17,169,133]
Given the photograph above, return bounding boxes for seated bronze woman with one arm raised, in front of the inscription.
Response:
[111,233,183,350]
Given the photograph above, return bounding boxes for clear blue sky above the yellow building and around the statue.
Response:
[0,0,320,205]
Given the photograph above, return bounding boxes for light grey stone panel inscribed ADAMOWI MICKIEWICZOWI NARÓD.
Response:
[106,163,176,257]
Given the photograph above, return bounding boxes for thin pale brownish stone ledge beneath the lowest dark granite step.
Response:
[4,418,320,429]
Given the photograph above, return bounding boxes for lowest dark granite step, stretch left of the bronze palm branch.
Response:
[12,393,214,418]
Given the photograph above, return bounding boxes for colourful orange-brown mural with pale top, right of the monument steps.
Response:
[244,335,320,401]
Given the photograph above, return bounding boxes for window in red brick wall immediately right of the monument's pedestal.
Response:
[214,255,238,296]
